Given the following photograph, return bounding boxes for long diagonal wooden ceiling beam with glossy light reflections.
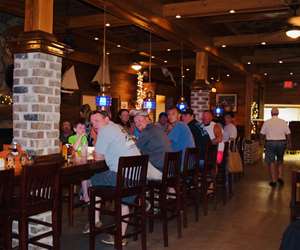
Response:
[83,0,248,74]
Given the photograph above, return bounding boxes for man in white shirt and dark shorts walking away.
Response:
[260,108,291,187]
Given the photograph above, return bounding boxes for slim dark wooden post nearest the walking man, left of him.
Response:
[245,75,254,140]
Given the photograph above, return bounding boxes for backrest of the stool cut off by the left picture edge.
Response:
[0,169,14,210]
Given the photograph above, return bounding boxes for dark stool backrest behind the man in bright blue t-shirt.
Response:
[183,148,200,176]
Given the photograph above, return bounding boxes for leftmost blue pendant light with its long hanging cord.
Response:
[96,6,111,110]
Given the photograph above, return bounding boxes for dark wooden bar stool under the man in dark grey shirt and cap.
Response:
[148,152,183,247]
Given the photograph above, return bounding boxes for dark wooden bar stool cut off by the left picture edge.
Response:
[0,169,14,250]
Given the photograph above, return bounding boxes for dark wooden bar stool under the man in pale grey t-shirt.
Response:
[89,155,149,250]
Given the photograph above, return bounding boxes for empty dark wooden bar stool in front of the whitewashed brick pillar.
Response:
[12,163,61,250]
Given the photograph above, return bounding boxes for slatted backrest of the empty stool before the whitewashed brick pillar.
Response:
[20,163,61,210]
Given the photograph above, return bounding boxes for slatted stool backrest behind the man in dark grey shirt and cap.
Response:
[162,152,181,185]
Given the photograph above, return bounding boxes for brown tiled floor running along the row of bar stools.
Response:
[62,156,300,250]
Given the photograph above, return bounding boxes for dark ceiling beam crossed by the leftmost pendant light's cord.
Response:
[67,14,130,29]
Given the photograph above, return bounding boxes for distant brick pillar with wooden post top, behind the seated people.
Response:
[191,52,210,120]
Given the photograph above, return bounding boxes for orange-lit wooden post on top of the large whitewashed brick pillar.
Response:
[24,0,53,34]
